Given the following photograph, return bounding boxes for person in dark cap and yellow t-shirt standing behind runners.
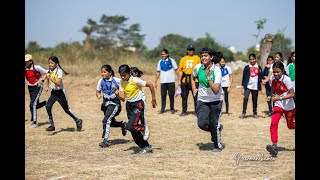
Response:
[178,44,201,116]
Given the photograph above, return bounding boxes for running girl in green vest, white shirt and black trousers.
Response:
[191,48,224,153]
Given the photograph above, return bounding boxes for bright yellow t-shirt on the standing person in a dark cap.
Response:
[179,55,201,83]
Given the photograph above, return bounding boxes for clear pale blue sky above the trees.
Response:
[25,0,295,52]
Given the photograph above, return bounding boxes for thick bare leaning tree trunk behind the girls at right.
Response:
[258,33,273,69]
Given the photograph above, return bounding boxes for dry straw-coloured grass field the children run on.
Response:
[25,70,295,180]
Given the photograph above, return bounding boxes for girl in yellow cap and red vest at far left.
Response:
[24,54,46,127]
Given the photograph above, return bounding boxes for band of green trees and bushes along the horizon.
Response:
[26,15,292,64]
